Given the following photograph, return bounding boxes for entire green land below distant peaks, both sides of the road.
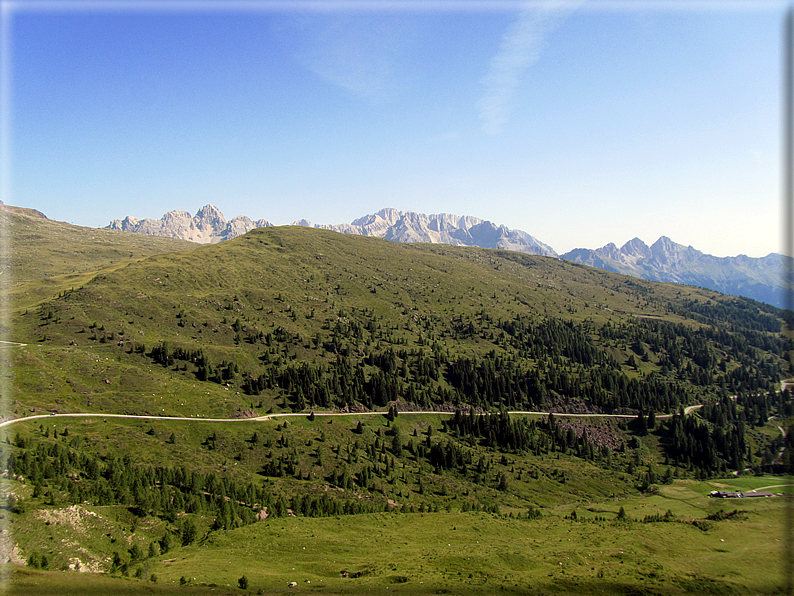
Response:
[0,217,794,594]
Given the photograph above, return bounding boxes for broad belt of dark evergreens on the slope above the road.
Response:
[144,312,785,412]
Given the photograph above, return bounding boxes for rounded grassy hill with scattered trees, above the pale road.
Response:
[14,228,789,414]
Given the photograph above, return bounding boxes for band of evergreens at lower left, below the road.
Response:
[3,428,402,544]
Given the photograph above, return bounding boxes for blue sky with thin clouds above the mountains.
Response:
[2,0,787,257]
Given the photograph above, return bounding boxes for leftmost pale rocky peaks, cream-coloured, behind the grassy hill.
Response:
[106,205,273,244]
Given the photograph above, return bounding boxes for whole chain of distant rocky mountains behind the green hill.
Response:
[107,205,785,308]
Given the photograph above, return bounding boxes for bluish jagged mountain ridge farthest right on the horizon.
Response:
[561,236,785,308]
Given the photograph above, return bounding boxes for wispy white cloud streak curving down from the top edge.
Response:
[477,1,581,134]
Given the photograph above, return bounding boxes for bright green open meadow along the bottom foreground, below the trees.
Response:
[4,482,784,595]
